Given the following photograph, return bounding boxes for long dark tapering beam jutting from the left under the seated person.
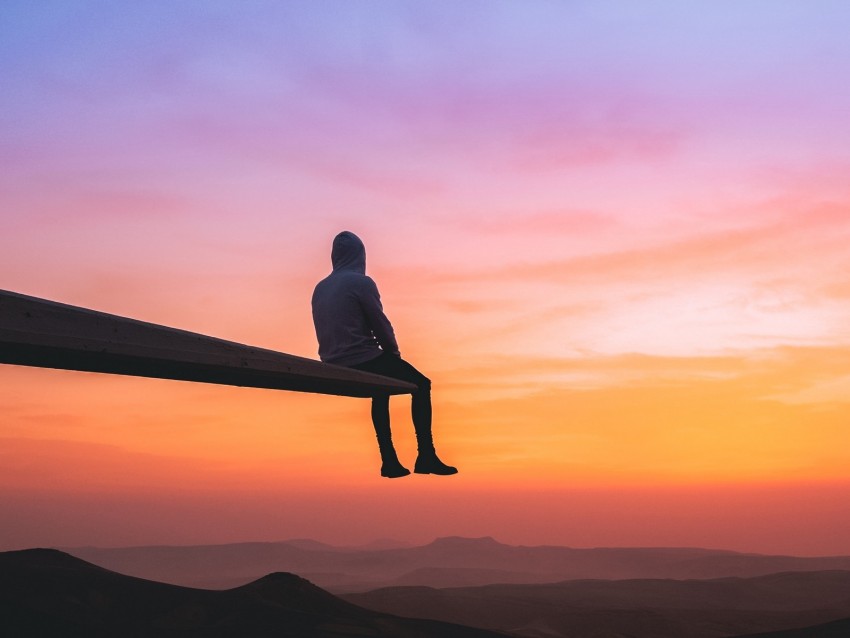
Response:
[0,290,416,397]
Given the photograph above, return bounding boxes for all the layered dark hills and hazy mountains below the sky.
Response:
[0,538,850,638]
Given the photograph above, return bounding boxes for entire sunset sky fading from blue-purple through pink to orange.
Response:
[0,0,850,555]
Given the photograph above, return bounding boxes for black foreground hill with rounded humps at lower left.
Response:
[0,549,500,638]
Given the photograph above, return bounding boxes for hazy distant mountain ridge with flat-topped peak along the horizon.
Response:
[66,537,850,593]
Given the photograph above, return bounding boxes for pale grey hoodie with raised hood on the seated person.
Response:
[312,231,399,366]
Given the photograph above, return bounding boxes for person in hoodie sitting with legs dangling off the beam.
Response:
[313,231,457,478]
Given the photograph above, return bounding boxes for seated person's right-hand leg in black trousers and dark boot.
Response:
[353,353,457,475]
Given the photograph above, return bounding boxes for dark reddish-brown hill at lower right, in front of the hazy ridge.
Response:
[343,571,850,638]
